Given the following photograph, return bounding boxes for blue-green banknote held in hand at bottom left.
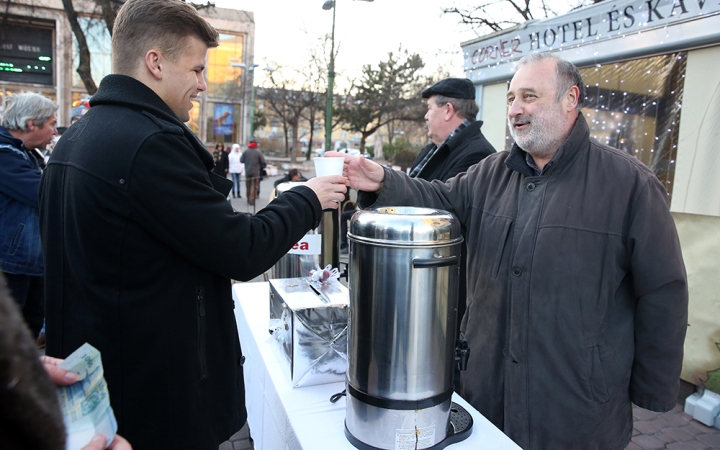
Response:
[58,342,117,450]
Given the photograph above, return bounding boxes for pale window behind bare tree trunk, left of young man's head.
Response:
[72,17,112,89]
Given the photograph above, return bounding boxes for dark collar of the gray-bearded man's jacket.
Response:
[505,114,590,177]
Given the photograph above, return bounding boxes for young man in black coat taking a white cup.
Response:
[40,0,346,450]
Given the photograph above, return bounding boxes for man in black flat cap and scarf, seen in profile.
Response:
[410,78,495,358]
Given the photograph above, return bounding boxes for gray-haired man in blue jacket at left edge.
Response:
[0,92,57,339]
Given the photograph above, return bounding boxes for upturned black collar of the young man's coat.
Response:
[90,74,214,169]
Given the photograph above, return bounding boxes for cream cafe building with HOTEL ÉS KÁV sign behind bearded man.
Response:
[461,0,720,392]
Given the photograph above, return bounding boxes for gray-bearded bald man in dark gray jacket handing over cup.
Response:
[328,53,688,450]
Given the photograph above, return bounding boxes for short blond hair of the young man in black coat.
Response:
[112,0,219,75]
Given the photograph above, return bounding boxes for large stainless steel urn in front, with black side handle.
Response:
[345,207,472,450]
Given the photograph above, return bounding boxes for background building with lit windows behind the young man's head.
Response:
[0,0,255,144]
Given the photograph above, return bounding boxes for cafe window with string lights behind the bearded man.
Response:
[506,52,687,201]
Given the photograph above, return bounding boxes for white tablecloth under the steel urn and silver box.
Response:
[233,283,520,450]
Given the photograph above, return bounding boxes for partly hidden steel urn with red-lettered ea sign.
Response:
[270,181,340,279]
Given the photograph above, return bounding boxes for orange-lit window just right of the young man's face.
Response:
[207,33,245,102]
